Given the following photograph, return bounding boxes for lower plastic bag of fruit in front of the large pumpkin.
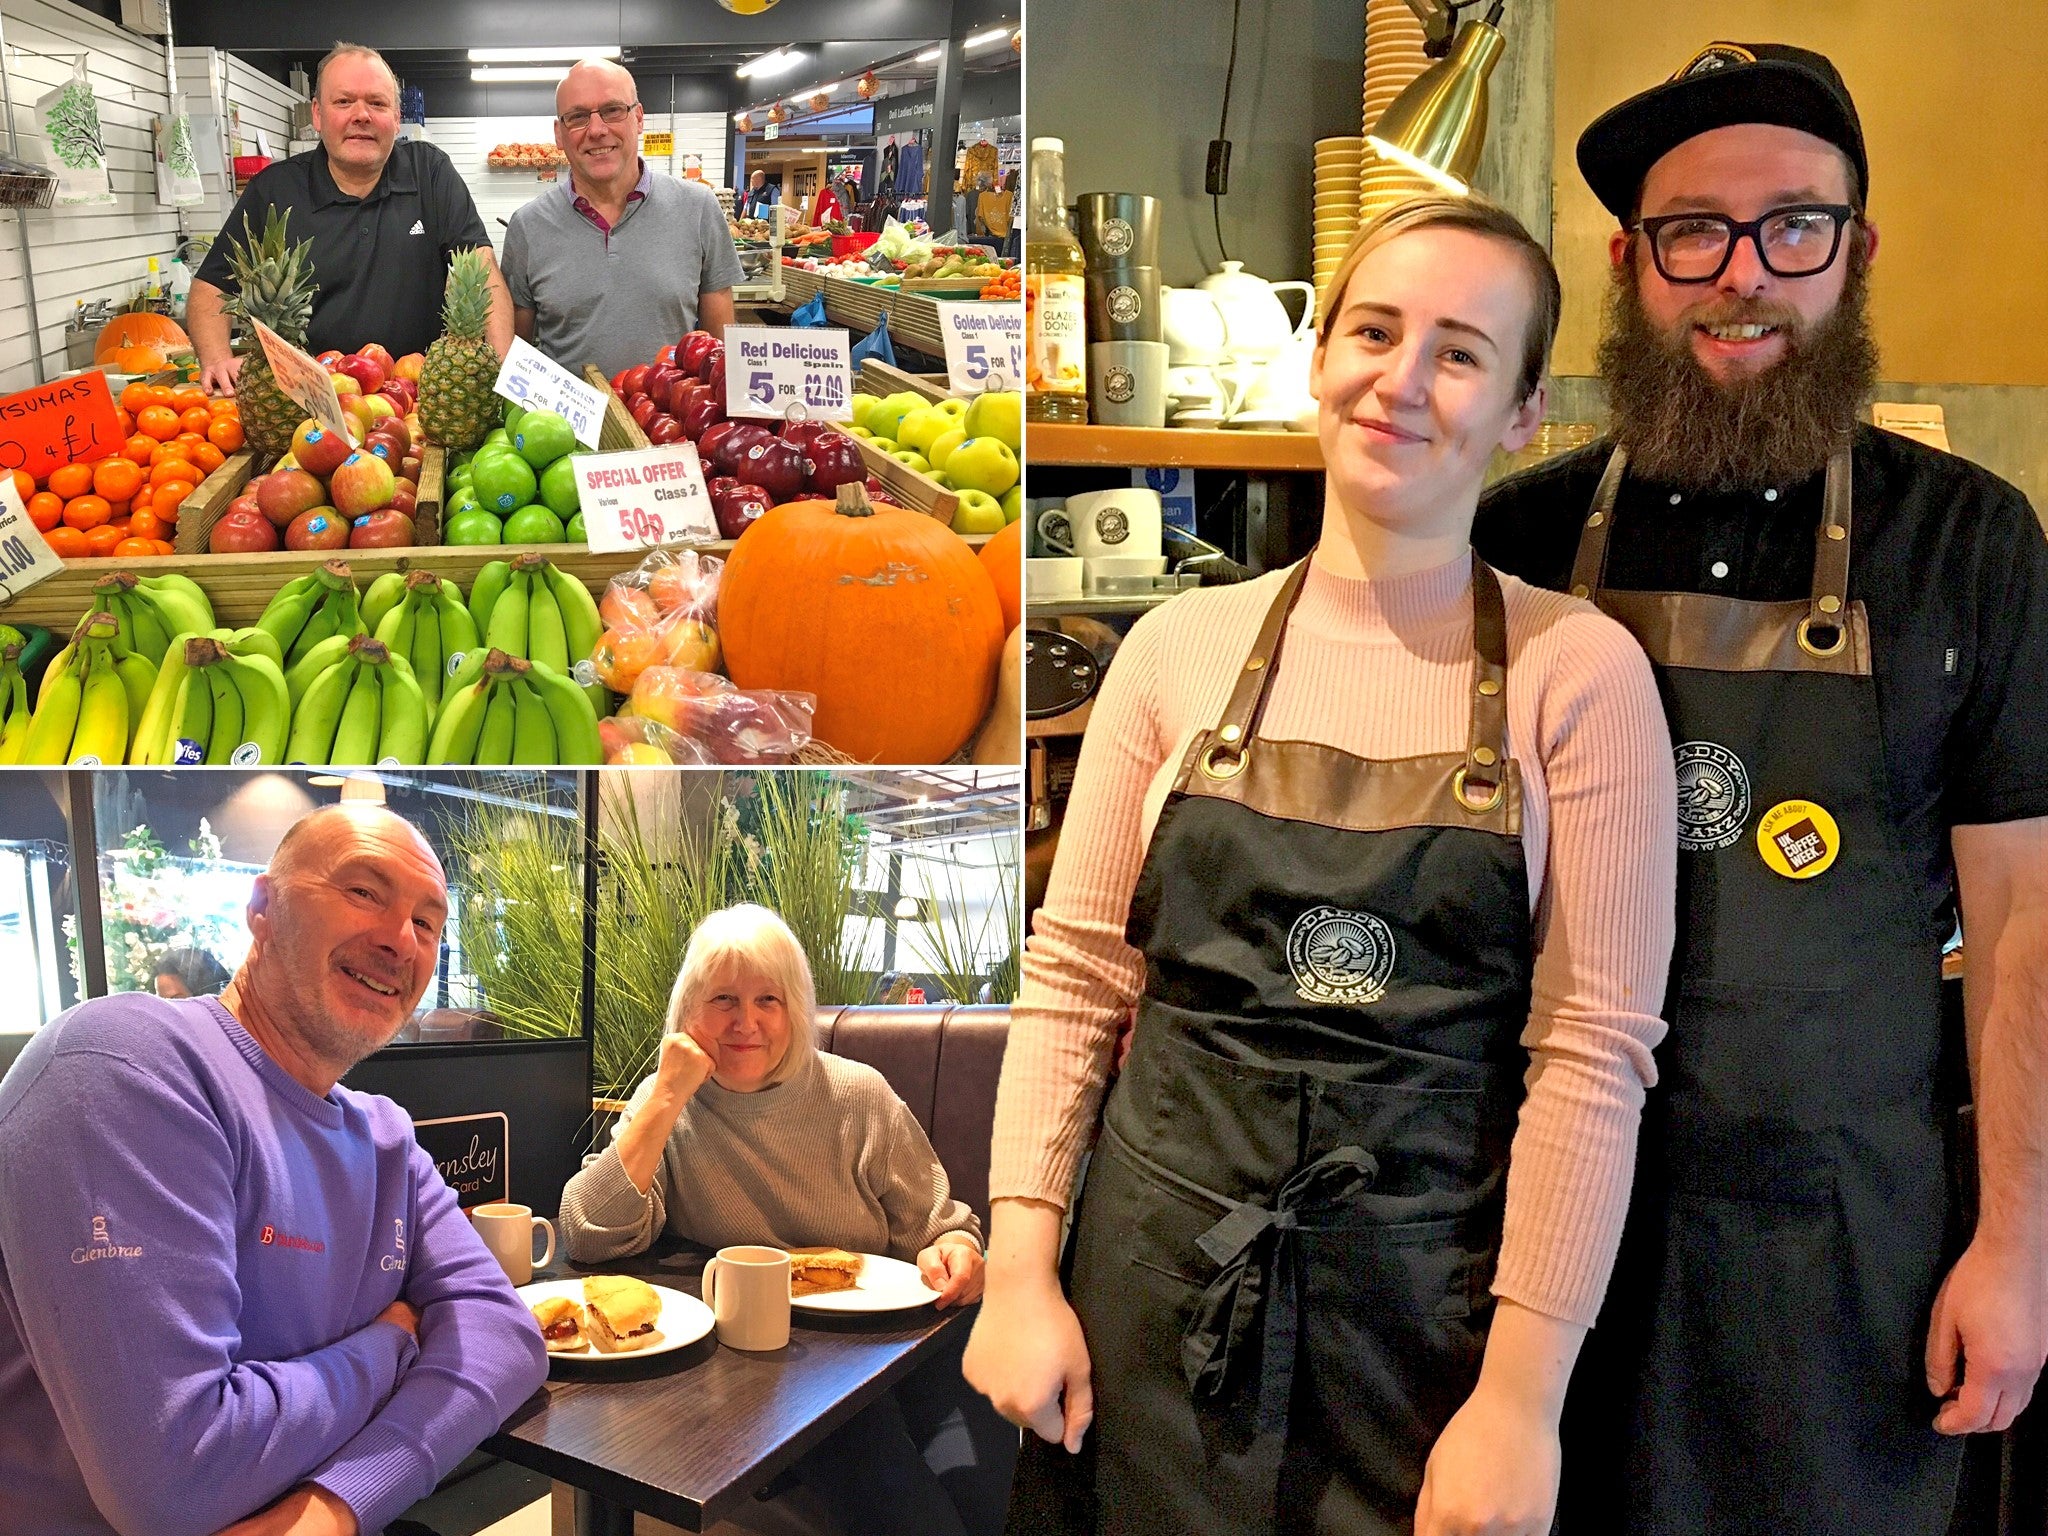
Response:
[598,666,817,766]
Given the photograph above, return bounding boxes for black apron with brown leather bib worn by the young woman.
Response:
[1010,559,1530,1536]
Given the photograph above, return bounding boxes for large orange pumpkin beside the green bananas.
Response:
[719,485,1004,762]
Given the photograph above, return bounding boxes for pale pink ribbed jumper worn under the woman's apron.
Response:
[989,555,1677,1323]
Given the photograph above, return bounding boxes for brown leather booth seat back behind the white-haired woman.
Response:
[817,1004,1010,1229]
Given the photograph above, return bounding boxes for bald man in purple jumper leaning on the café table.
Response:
[0,805,547,1536]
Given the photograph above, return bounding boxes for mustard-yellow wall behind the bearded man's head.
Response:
[1548,0,2048,385]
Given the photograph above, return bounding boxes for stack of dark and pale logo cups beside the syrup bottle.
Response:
[1075,193,1167,426]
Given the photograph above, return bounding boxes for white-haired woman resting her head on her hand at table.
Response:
[561,905,1016,1536]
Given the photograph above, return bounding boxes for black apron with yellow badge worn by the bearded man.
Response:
[1561,446,1960,1536]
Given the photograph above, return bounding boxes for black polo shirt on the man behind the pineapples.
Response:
[195,139,492,356]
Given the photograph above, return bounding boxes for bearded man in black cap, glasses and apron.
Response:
[1475,43,2048,1536]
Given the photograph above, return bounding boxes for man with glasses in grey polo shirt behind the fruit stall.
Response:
[504,59,741,375]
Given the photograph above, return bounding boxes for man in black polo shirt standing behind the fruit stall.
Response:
[186,43,512,393]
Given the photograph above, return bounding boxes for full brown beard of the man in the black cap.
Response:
[1599,231,1878,492]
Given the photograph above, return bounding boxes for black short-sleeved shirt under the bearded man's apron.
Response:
[1473,426,2048,942]
